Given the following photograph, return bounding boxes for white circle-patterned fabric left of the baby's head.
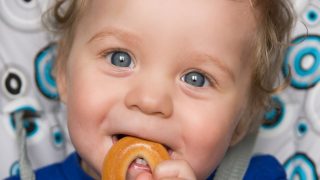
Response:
[0,0,72,179]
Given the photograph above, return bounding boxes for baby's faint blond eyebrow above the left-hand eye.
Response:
[87,26,141,46]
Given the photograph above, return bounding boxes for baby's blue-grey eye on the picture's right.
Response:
[181,71,208,87]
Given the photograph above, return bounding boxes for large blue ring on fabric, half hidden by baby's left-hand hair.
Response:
[35,44,58,100]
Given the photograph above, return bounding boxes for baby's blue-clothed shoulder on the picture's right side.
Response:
[244,155,287,180]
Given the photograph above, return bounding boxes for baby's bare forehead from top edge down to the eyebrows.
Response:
[80,0,256,47]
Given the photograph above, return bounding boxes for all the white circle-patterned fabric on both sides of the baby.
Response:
[0,0,320,180]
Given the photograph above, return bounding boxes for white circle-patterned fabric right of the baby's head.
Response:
[255,0,320,180]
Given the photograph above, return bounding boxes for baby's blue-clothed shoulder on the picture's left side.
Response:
[8,153,92,180]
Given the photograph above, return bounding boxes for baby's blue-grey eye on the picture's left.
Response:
[111,51,133,67]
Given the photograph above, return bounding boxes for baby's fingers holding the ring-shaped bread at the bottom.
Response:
[136,160,196,180]
